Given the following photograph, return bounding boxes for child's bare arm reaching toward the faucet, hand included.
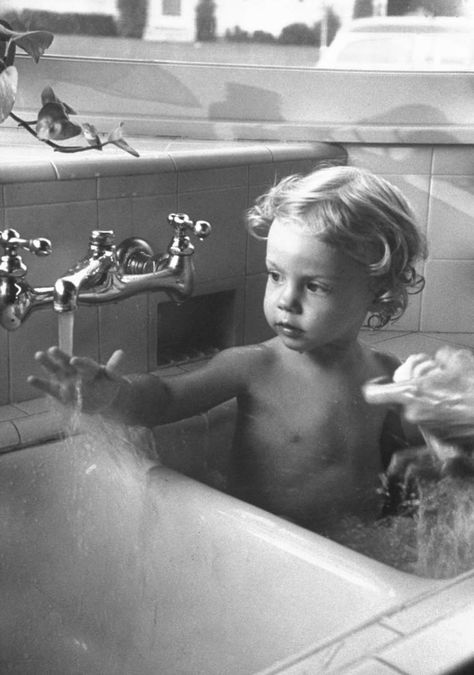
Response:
[28,347,252,427]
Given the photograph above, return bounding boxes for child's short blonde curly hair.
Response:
[247,166,426,328]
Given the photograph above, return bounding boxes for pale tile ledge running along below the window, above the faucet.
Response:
[0,128,346,183]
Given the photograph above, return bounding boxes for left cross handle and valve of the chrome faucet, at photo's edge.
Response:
[0,229,53,331]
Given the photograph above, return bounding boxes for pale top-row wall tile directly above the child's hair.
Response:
[345,143,433,175]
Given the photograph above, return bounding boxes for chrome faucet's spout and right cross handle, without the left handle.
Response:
[53,213,211,312]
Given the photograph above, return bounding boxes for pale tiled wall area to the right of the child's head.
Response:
[346,144,474,334]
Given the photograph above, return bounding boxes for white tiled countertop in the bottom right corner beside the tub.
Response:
[259,570,474,675]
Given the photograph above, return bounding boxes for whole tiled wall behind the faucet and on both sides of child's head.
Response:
[0,143,474,404]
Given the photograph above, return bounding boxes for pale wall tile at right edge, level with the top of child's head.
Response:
[428,176,474,259]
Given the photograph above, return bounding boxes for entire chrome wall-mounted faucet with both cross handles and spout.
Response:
[0,213,211,331]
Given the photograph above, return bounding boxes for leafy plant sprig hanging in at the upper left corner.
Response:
[0,20,139,157]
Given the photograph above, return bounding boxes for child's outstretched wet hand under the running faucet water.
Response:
[28,347,123,413]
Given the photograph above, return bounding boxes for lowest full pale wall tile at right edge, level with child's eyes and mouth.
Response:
[421,260,474,333]
